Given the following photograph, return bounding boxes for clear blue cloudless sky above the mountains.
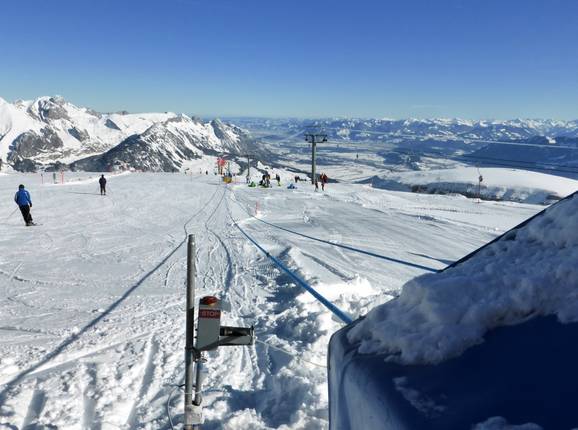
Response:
[0,0,578,119]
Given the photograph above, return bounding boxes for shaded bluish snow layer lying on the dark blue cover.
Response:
[348,194,578,364]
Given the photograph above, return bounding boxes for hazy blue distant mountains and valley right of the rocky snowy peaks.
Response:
[234,118,578,178]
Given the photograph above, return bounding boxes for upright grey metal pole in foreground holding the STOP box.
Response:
[183,234,196,430]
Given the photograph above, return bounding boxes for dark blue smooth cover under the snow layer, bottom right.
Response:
[329,316,578,430]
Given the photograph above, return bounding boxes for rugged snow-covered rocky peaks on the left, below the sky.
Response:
[0,97,259,171]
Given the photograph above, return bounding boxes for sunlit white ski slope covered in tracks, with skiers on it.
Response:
[0,170,540,430]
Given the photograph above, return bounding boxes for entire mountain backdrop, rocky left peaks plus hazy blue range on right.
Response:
[0,96,578,171]
